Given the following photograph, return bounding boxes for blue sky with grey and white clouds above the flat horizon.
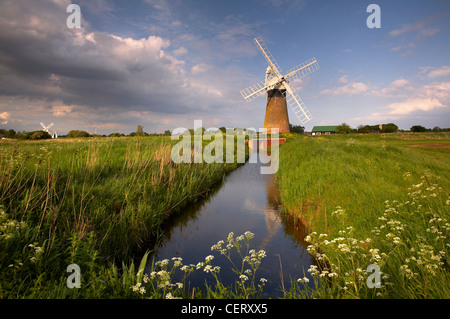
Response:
[0,0,450,134]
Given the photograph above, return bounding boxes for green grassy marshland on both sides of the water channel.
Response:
[0,133,450,298]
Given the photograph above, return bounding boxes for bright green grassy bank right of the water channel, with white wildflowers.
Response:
[277,134,450,298]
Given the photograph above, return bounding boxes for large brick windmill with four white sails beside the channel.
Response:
[241,37,319,133]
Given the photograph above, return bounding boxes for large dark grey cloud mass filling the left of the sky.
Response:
[0,0,250,134]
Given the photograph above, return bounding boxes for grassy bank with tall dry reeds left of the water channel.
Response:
[0,137,246,298]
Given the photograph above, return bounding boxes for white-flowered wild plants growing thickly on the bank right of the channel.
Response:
[298,172,450,297]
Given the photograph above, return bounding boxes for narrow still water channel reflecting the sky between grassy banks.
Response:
[149,152,312,298]
